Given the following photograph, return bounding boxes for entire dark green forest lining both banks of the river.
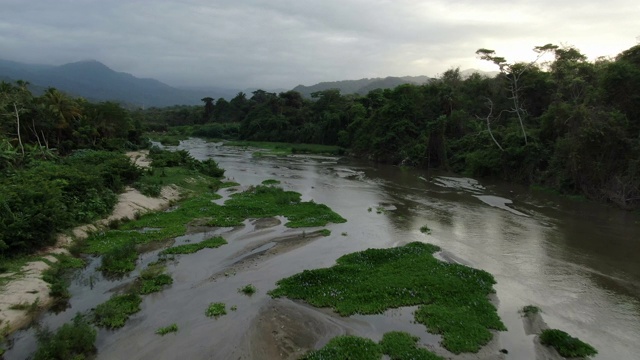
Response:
[0,45,640,253]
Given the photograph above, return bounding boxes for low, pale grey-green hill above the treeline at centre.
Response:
[293,76,432,98]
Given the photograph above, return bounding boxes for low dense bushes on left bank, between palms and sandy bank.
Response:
[0,151,141,255]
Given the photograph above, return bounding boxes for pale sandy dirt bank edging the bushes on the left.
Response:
[0,151,180,332]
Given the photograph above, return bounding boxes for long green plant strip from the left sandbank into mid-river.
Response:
[86,183,346,274]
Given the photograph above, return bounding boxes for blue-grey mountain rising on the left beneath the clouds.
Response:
[0,60,239,107]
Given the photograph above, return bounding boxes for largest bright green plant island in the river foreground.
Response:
[269,242,506,354]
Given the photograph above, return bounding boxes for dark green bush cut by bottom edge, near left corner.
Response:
[33,314,96,360]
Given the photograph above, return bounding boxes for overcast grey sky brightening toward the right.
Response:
[0,0,640,89]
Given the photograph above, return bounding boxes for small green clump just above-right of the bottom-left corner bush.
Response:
[93,293,142,329]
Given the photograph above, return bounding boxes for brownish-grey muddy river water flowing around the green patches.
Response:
[5,139,640,360]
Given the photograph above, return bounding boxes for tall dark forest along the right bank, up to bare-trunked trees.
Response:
[140,45,640,208]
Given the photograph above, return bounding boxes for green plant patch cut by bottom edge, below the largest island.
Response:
[302,331,444,360]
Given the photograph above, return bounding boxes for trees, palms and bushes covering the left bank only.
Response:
[0,82,148,260]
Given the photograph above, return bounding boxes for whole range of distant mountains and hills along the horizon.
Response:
[0,59,494,107]
